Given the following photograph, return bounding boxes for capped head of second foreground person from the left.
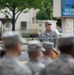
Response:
[28,40,45,58]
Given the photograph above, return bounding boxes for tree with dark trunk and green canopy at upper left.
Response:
[0,0,43,31]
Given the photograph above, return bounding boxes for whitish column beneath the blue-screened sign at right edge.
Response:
[62,18,74,34]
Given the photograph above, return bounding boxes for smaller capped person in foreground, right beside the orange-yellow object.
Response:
[41,42,55,65]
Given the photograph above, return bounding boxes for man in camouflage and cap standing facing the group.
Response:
[38,22,58,48]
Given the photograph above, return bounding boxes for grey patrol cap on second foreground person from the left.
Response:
[28,40,45,52]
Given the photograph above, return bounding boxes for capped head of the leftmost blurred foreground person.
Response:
[3,31,23,54]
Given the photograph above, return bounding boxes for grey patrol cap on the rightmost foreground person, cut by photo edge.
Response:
[58,35,74,47]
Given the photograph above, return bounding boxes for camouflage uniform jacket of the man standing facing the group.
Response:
[38,30,58,48]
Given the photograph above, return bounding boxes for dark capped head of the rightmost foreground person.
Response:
[58,35,74,54]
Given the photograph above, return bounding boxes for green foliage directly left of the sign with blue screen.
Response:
[36,0,53,20]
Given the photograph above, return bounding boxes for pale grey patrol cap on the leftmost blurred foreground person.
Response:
[3,31,23,46]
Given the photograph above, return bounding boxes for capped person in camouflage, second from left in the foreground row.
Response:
[27,41,45,75]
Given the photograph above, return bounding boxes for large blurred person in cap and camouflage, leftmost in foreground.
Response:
[0,32,31,75]
